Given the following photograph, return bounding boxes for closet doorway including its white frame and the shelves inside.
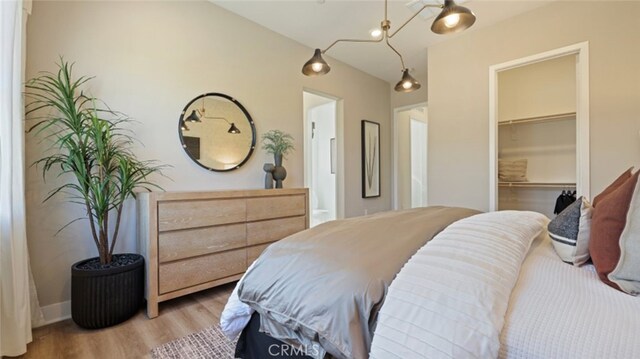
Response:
[489,42,589,217]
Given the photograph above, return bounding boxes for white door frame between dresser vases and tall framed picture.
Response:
[302,87,345,219]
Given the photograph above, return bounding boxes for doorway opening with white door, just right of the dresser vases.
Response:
[303,91,339,227]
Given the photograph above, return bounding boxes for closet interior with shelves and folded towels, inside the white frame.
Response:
[496,55,577,217]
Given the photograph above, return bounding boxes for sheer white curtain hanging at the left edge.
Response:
[0,0,39,356]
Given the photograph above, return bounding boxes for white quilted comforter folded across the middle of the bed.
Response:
[370,211,548,359]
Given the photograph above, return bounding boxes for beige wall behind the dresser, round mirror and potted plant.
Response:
[26,1,391,305]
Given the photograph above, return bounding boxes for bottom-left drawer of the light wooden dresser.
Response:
[159,248,247,294]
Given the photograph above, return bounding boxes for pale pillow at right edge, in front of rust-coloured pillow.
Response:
[607,174,640,295]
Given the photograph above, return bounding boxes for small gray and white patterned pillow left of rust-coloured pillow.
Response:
[547,197,593,266]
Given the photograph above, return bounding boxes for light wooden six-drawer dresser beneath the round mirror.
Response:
[138,188,309,318]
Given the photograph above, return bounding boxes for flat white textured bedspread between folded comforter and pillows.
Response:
[500,229,640,359]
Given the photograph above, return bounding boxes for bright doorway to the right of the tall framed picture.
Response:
[394,104,428,209]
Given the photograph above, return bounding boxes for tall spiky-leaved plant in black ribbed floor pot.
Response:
[26,59,161,329]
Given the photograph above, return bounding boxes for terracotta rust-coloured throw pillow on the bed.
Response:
[589,171,640,289]
